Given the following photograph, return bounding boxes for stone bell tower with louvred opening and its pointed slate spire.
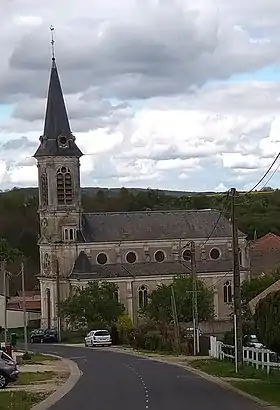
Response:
[34,28,83,277]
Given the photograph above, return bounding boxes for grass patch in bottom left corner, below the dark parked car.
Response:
[0,391,49,410]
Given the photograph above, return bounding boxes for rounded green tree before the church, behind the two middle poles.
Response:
[142,276,214,323]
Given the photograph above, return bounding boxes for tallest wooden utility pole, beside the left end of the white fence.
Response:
[231,188,243,372]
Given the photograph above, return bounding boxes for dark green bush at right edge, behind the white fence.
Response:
[254,291,280,354]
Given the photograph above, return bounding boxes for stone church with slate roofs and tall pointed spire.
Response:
[34,57,249,327]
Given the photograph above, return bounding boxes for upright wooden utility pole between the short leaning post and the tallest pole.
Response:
[191,241,200,356]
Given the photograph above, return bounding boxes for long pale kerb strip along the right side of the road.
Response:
[100,347,280,410]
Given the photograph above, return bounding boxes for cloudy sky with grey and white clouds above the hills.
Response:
[0,0,280,191]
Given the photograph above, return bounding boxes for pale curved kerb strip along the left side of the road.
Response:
[31,353,82,410]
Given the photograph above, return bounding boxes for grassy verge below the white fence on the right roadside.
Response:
[190,359,280,406]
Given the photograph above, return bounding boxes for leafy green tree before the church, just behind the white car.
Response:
[61,281,124,329]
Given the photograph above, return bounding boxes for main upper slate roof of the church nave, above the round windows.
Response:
[82,210,246,242]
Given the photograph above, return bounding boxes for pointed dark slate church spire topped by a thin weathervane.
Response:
[34,26,83,158]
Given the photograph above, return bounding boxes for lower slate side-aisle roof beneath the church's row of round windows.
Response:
[71,252,241,279]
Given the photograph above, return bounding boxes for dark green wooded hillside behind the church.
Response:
[0,188,280,288]
